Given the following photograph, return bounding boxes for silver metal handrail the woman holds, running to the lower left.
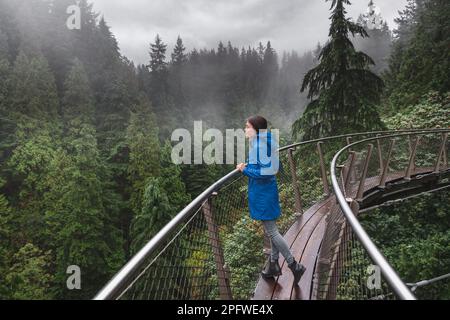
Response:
[94,129,446,300]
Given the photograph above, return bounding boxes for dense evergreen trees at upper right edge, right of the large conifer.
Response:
[385,0,450,113]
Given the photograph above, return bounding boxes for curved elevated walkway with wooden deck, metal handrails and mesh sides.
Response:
[94,129,450,300]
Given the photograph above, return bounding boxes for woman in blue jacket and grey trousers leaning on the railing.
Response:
[236,116,306,285]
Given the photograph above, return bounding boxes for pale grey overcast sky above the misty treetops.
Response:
[92,0,407,64]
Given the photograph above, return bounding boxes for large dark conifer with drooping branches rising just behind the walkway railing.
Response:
[293,0,383,139]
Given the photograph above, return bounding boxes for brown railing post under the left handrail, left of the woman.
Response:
[202,192,232,300]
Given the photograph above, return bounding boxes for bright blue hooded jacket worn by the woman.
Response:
[242,132,281,221]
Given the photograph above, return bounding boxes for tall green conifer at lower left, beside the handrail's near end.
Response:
[45,121,124,298]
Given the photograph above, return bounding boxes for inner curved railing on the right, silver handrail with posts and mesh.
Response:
[316,129,450,299]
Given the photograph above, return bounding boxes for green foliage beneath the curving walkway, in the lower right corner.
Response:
[361,190,450,299]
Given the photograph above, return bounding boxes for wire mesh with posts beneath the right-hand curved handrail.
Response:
[314,133,449,300]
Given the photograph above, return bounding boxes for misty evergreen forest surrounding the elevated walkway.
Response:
[0,0,450,300]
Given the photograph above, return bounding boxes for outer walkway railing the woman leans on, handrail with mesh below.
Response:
[94,129,448,300]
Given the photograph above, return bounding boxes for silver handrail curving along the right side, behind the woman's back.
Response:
[330,129,450,300]
